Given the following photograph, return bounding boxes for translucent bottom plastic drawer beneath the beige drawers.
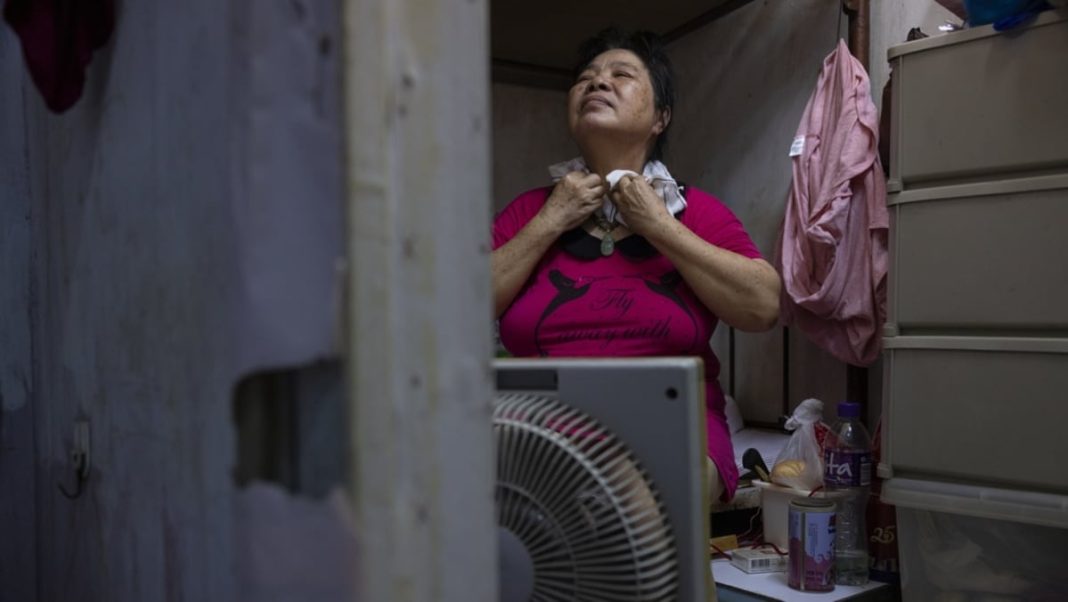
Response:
[882,479,1068,602]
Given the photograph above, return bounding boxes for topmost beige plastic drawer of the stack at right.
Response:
[889,11,1068,190]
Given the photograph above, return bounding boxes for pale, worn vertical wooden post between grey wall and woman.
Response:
[343,0,497,602]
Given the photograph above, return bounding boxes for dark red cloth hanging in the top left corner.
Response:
[3,0,115,113]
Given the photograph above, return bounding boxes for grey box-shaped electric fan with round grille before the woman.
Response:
[493,358,711,602]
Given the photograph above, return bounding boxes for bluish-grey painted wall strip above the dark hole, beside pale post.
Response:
[229,0,344,373]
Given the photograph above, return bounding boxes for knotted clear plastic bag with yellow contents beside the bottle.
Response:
[771,399,823,491]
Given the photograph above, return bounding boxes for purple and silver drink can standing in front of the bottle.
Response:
[786,497,834,591]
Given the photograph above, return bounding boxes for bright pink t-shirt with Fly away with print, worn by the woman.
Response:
[493,188,760,500]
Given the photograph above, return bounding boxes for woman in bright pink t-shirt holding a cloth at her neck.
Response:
[491,29,780,500]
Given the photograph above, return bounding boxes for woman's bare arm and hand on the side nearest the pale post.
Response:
[489,172,606,318]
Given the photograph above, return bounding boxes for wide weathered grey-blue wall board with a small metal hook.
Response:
[20,2,237,602]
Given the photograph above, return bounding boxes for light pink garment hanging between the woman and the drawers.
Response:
[776,41,889,366]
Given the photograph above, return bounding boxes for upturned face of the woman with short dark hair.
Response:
[567,49,666,152]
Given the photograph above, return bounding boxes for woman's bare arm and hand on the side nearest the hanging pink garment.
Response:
[612,177,782,332]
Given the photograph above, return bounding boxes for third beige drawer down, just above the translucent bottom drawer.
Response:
[879,336,1068,494]
